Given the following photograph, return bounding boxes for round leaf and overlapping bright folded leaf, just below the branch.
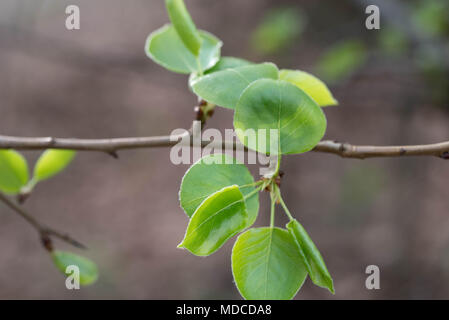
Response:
[180,154,259,256]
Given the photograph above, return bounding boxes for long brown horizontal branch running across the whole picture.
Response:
[0,134,449,159]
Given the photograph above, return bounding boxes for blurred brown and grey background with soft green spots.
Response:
[0,0,449,299]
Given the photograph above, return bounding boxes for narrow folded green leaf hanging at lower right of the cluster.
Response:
[287,220,335,294]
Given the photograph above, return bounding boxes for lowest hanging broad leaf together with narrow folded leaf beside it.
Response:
[232,220,334,300]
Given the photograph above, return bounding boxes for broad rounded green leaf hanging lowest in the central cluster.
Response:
[232,228,307,300]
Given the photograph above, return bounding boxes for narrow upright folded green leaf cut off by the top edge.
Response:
[165,0,202,56]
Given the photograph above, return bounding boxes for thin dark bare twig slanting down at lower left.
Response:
[0,192,86,251]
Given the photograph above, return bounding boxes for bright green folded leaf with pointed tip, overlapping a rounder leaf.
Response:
[178,186,248,256]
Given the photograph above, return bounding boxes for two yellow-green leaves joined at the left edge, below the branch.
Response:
[0,149,75,194]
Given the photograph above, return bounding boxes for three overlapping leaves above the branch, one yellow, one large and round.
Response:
[190,63,337,155]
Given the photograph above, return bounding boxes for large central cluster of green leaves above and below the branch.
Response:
[145,0,337,299]
